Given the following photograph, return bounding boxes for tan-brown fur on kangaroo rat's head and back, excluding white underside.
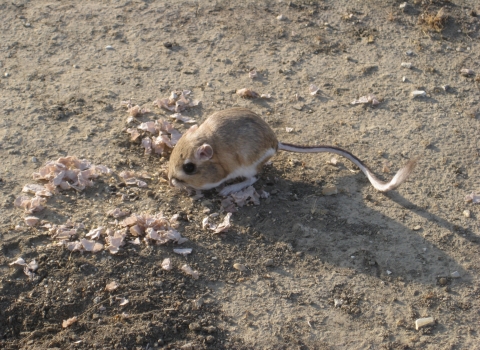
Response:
[168,108,278,188]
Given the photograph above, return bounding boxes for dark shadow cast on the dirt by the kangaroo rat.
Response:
[218,165,472,285]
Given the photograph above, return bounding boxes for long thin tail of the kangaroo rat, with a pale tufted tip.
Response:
[278,142,418,192]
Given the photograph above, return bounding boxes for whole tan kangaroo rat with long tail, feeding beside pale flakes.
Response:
[168,108,416,196]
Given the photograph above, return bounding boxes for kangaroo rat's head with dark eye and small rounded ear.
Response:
[168,125,227,190]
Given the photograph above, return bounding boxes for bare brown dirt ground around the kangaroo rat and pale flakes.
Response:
[0,0,480,349]
